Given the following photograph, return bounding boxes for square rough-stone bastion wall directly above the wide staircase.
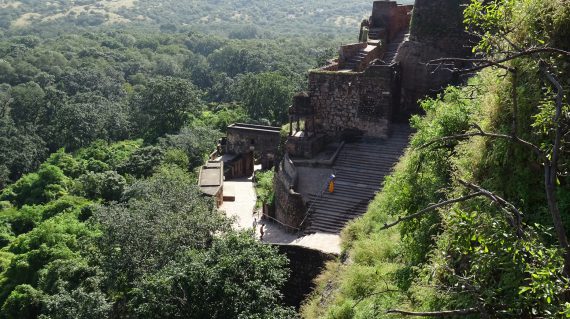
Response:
[309,65,398,137]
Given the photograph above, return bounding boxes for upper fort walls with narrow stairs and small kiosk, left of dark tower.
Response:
[287,1,413,157]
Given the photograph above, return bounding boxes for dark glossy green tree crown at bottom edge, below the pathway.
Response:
[130,232,294,318]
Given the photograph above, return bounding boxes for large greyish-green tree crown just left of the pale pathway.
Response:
[95,169,229,287]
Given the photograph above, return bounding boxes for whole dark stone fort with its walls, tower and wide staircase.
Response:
[205,0,471,233]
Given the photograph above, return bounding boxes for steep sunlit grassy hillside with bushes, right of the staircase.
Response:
[302,0,570,319]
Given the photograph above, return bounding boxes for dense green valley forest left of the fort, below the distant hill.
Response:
[0,1,341,318]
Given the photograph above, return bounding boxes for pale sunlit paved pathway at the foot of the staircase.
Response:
[220,171,340,254]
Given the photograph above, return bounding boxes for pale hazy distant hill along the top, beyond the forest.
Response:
[0,0,413,38]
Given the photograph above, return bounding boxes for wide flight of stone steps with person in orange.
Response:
[305,124,411,234]
